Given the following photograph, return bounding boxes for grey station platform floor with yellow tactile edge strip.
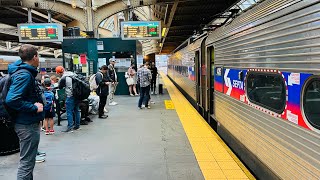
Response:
[0,75,255,180]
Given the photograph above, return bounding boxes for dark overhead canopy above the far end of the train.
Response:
[158,0,239,53]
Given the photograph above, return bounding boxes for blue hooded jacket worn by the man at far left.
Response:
[6,60,44,125]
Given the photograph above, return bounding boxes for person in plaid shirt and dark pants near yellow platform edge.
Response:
[137,62,152,109]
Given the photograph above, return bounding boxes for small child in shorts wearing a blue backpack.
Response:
[43,78,55,135]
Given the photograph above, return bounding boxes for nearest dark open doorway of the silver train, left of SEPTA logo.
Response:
[207,46,214,124]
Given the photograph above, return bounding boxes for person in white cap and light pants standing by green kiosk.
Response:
[108,58,118,106]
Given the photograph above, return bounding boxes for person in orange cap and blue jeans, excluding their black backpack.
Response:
[56,66,80,132]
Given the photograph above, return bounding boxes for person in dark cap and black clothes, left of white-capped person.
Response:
[96,65,110,119]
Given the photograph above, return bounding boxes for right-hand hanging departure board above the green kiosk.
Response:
[121,21,161,40]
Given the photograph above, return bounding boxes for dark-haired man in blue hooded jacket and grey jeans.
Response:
[6,45,44,180]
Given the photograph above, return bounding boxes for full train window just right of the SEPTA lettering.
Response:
[246,72,286,113]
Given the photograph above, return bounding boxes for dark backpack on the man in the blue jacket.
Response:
[0,69,33,126]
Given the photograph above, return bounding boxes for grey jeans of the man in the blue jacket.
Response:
[15,123,40,180]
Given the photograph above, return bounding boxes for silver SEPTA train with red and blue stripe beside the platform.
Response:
[168,0,320,179]
